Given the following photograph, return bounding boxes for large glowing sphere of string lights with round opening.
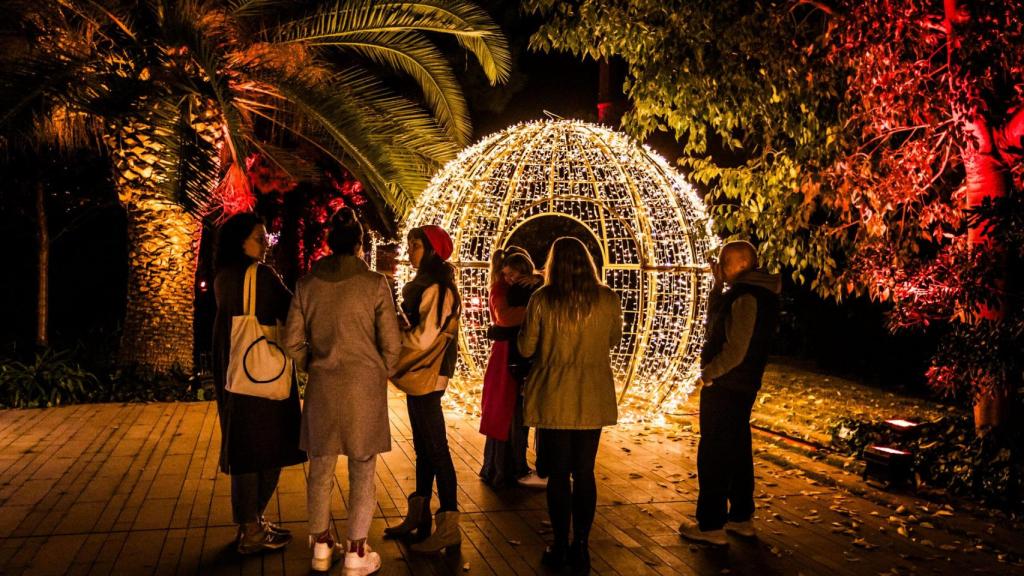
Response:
[399,120,717,419]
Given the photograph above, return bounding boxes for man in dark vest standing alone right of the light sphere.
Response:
[679,242,781,545]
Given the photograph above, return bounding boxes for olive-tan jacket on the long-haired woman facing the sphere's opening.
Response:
[517,286,623,429]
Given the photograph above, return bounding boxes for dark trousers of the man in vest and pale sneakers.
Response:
[697,384,758,530]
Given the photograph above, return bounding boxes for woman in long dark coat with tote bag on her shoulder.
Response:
[212,212,306,554]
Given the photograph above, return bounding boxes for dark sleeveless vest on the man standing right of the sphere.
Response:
[700,284,779,392]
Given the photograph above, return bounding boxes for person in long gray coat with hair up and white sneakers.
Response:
[285,208,401,576]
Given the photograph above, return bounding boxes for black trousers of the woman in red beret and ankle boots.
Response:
[406,390,459,511]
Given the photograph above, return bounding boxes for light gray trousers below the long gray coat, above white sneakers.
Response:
[306,454,377,540]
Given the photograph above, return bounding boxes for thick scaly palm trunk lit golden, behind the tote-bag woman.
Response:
[118,199,202,373]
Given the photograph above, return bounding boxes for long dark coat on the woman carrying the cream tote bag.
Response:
[213,264,306,474]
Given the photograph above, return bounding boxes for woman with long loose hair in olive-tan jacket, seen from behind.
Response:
[518,237,623,574]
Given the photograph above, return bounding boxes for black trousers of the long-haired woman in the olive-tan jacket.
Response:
[537,428,601,547]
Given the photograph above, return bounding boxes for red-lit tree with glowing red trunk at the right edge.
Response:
[816,0,1024,424]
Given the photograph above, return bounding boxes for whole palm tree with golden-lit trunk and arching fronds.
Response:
[0,0,510,371]
